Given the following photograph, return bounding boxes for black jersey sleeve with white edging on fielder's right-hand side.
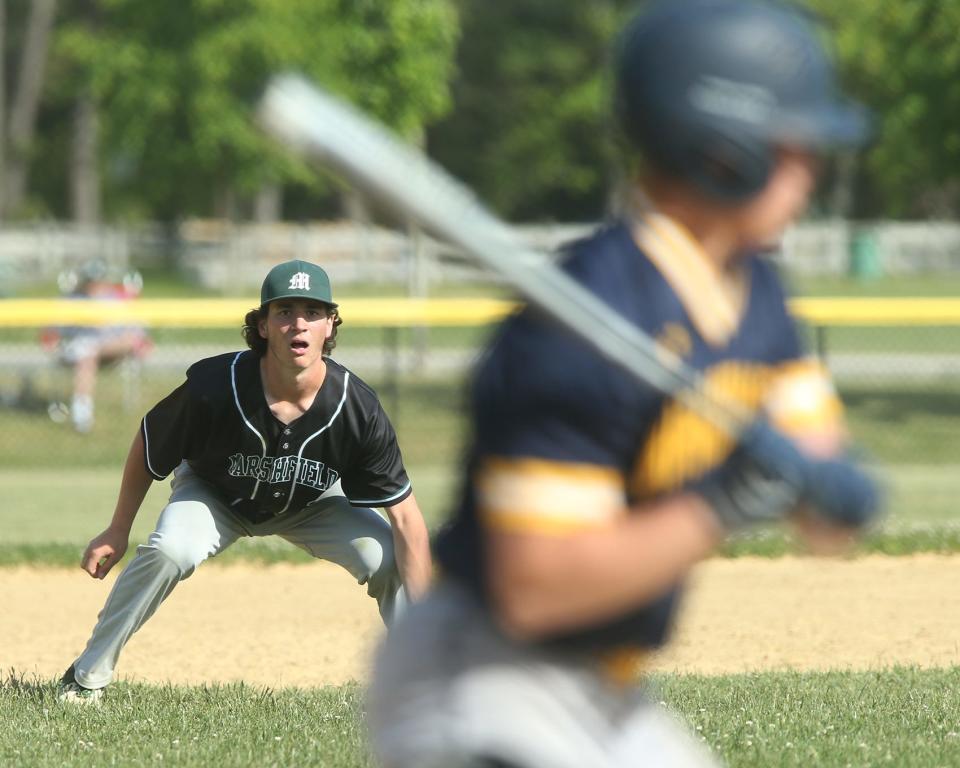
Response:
[341,403,411,507]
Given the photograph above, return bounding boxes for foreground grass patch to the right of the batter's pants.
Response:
[659,668,960,768]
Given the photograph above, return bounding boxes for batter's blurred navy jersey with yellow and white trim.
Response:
[436,215,840,648]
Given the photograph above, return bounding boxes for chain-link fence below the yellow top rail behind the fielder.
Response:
[0,314,960,522]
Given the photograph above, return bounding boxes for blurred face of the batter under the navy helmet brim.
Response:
[736,149,820,249]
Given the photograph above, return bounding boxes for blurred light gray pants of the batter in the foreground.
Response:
[367,583,718,768]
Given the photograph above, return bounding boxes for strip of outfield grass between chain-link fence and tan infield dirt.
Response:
[0,464,960,567]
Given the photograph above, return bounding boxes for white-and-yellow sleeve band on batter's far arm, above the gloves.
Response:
[763,358,843,433]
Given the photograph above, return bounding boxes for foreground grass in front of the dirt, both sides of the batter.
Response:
[0,668,960,768]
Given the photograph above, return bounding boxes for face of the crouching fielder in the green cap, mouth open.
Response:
[259,299,333,370]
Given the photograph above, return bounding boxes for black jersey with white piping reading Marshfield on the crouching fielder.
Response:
[140,350,411,522]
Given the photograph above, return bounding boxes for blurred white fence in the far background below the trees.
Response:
[0,221,960,296]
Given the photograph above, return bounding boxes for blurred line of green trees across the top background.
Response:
[0,0,960,224]
